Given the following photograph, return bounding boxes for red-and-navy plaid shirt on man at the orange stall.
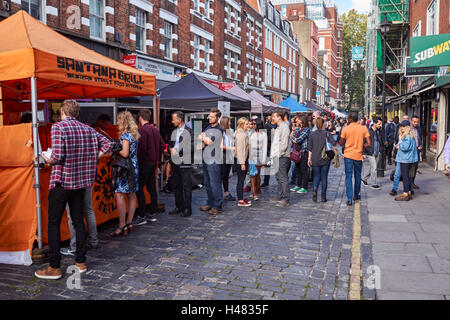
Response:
[49,118,112,190]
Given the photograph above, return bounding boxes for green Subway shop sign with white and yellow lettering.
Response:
[410,33,450,68]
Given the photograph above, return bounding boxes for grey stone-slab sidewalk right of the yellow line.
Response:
[363,163,450,300]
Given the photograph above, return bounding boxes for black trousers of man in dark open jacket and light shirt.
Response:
[172,165,192,212]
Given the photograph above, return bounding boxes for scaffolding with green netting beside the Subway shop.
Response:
[364,0,409,114]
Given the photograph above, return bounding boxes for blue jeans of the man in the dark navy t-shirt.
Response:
[203,162,223,210]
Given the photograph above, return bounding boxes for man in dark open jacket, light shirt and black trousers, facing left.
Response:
[169,111,194,217]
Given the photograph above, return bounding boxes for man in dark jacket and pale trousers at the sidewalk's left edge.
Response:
[362,117,383,190]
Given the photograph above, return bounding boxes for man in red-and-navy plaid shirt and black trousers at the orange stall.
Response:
[35,100,112,280]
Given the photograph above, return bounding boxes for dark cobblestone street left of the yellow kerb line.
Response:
[0,162,375,300]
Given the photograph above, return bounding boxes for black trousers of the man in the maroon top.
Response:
[137,164,158,217]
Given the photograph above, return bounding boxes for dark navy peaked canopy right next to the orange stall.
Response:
[141,73,251,111]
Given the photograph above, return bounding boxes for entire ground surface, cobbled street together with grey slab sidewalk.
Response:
[0,158,450,300]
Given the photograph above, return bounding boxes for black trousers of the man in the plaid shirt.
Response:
[48,183,87,268]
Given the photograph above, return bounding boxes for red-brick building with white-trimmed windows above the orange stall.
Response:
[0,0,264,91]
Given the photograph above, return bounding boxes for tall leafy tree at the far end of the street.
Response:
[340,9,367,112]
